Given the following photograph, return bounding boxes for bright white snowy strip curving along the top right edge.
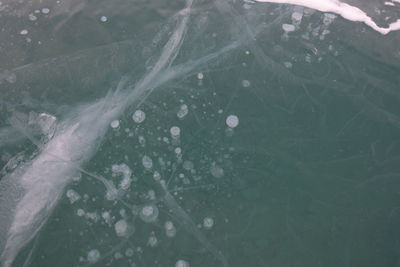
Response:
[255,0,400,35]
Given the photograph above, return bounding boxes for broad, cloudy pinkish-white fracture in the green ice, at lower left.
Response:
[0,97,126,267]
